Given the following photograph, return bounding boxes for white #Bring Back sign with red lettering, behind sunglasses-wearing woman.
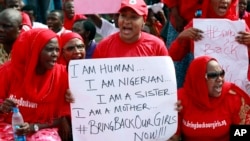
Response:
[194,19,248,91]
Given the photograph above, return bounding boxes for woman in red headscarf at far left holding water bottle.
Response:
[0,29,70,141]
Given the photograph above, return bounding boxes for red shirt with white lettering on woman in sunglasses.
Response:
[178,85,241,141]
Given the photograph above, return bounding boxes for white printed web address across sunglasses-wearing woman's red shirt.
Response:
[182,120,227,130]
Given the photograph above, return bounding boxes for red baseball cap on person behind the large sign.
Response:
[119,0,148,18]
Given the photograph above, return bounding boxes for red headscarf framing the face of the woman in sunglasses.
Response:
[180,56,226,109]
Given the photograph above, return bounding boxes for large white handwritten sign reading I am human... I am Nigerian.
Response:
[69,57,178,141]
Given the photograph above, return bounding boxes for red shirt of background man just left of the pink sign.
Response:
[63,14,87,30]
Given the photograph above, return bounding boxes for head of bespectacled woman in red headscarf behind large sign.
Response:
[58,32,86,65]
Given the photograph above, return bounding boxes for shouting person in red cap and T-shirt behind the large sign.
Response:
[93,0,168,58]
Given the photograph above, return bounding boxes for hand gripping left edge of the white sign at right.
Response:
[177,27,203,41]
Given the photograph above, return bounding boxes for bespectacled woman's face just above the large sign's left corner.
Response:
[63,38,86,63]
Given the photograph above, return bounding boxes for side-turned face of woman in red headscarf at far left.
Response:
[37,37,59,72]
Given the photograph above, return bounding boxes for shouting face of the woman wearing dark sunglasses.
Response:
[206,60,225,97]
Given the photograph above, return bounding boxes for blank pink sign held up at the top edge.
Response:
[74,0,122,14]
